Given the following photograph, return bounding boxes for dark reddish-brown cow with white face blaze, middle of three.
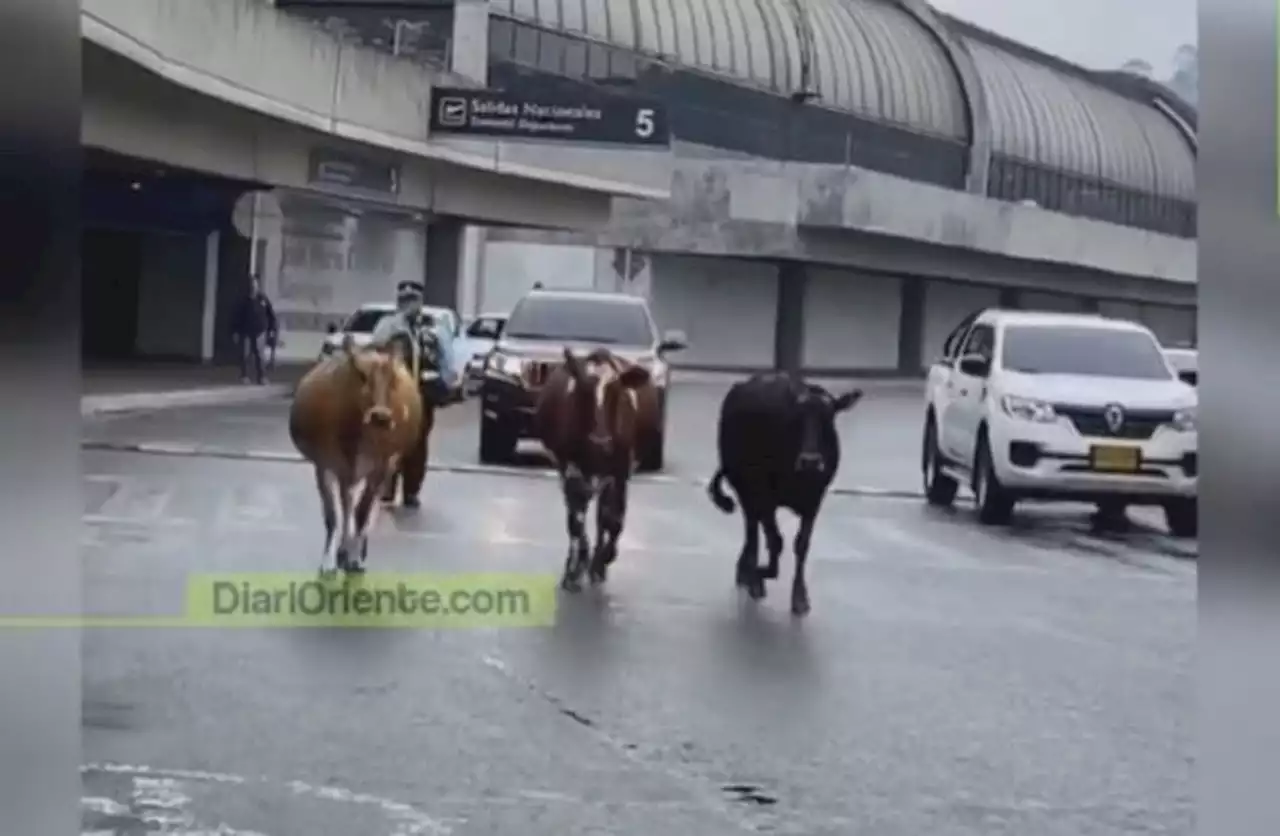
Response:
[534,348,658,591]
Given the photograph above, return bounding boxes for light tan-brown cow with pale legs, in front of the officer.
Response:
[289,337,422,575]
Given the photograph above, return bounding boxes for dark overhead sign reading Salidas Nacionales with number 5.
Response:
[428,87,671,146]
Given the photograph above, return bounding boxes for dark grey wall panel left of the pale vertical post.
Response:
[134,227,207,360]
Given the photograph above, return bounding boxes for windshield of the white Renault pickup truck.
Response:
[1000,325,1172,380]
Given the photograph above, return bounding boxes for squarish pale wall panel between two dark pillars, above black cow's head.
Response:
[803,268,902,369]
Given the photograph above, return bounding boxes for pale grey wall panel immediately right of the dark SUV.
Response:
[646,255,778,369]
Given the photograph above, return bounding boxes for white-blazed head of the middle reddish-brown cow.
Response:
[564,348,650,458]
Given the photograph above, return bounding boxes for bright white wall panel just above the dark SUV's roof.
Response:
[476,241,595,312]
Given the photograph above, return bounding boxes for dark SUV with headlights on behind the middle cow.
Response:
[480,289,686,471]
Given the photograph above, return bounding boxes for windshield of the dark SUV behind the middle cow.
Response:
[504,296,654,346]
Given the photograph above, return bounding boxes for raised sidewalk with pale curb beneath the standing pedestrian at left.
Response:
[81,362,308,417]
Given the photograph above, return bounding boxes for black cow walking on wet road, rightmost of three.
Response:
[707,374,863,616]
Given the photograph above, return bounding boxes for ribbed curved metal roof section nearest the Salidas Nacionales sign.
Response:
[490,0,968,140]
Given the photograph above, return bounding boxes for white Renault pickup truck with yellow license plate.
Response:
[920,310,1198,536]
